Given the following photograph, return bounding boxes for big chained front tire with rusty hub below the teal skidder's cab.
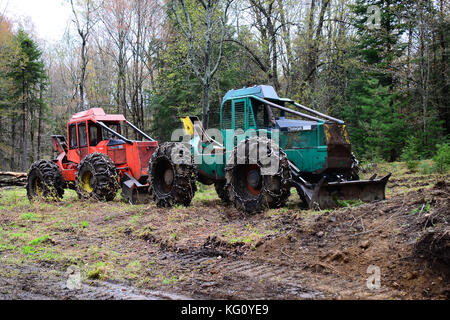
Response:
[225,137,291,213]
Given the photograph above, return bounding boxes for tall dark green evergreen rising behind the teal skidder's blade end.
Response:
[342,0,414,161]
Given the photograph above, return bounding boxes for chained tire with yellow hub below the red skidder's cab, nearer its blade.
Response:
[76,152,120,201]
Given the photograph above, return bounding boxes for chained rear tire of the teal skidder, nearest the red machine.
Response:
[148,142,197,208]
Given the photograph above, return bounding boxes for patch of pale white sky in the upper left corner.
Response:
[0,0,72,42]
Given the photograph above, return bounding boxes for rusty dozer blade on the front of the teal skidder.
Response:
[300,174,391,209]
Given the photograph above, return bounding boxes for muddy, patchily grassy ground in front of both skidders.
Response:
[0,163,450,299]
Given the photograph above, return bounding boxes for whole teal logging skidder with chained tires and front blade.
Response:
[149,85,390,213]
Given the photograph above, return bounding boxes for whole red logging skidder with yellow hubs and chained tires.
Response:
[26,108,163,204]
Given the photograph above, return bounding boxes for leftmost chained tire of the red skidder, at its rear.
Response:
[26,160,65,201]
